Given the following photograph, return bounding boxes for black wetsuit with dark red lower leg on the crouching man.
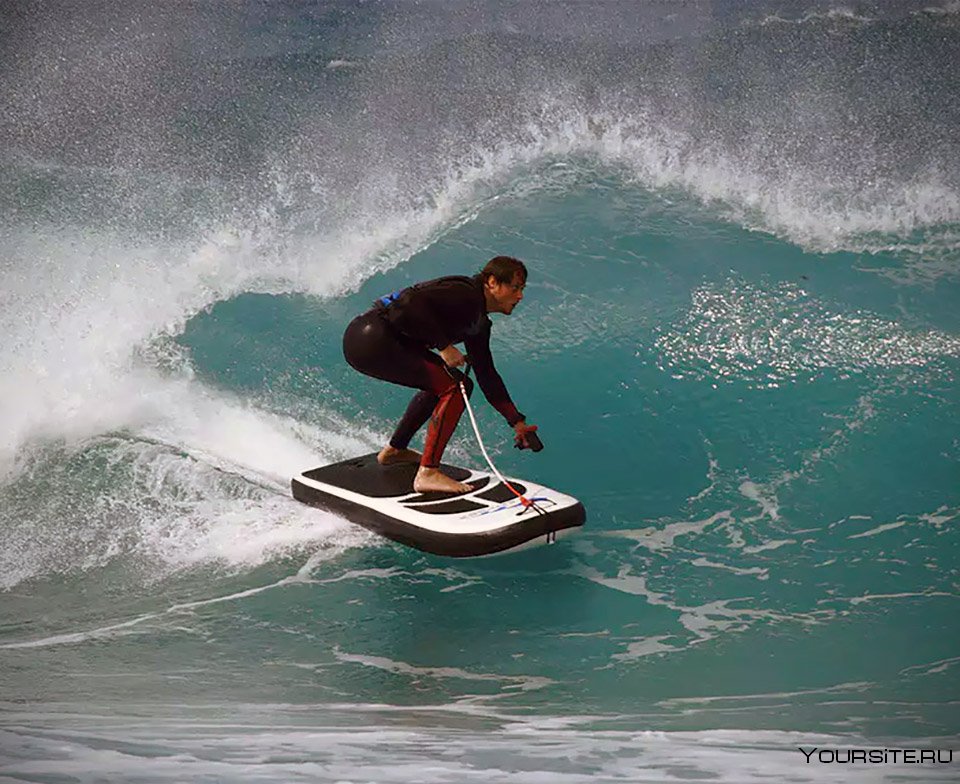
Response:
[343,275,524,468]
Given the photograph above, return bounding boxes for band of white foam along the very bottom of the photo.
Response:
[0,716,955,784]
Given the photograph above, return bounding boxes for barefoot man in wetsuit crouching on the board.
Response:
[343,256,537,493]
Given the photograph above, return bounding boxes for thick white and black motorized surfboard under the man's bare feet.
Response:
[291,453,586,558]
